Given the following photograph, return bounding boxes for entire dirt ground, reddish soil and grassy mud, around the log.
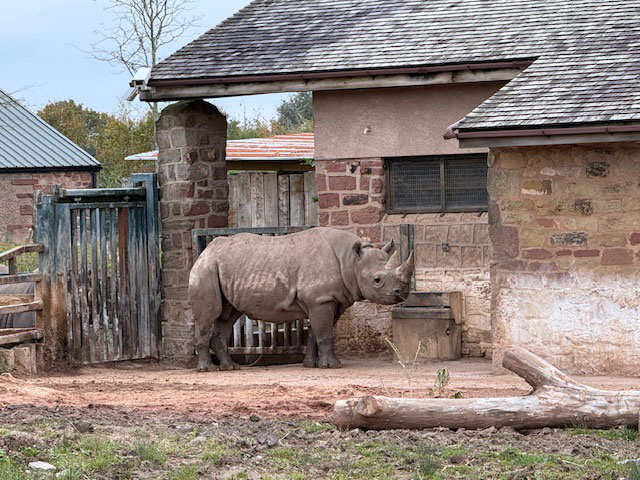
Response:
[0,359,640,480]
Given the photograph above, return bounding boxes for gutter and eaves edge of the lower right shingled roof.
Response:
[444,124,640,148]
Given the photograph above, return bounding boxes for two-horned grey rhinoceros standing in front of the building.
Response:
[189,227,413,371]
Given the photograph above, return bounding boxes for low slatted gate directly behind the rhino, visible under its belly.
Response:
[192,226,311,355]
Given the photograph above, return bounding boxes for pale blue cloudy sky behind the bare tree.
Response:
[0,0,287,119]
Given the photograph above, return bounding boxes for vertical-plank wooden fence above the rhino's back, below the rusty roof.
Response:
[228,172,318,228]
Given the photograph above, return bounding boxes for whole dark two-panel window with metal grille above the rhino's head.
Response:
[385,153,489,213]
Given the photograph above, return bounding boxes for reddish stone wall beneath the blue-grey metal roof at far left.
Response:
[0,171,92,243]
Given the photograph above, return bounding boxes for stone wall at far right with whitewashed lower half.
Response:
[488,143,640,375]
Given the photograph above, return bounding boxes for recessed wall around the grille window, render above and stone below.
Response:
[313,83,503,357]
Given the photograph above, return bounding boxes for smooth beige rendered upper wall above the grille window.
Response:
[313,82,504,160]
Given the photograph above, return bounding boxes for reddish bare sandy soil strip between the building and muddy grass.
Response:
[0,359,640,419]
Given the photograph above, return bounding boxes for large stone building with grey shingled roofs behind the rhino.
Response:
[135,0,640,373]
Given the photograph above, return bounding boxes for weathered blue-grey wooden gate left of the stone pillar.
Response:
[36,174,160,365]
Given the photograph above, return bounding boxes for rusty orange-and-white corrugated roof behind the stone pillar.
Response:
[125,133,314,161]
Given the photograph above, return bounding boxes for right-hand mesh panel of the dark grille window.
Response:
[444,155,489,209]
